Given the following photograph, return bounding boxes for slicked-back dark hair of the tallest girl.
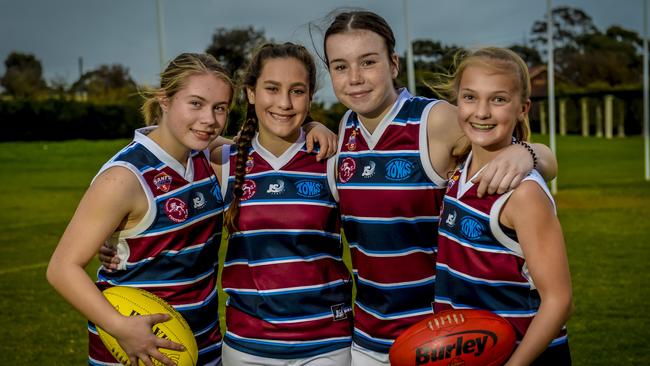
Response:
[323,10,395,65]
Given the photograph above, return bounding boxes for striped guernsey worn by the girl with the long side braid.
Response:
[222,133,352,359]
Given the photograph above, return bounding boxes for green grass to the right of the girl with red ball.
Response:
[532,136,650,365]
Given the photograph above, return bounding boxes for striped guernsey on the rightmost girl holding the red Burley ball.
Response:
[435,154,569,364]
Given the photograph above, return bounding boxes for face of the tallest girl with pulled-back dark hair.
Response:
[325,30,399,123]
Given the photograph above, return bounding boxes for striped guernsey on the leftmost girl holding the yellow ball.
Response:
[88,127,223,365]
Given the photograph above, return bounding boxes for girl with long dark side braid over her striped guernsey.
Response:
[218,43,352,365]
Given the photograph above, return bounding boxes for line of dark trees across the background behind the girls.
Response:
[0,6,643,142]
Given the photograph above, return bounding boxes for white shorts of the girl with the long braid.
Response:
[221,342,350,366]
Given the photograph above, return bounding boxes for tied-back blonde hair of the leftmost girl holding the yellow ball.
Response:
[140,53,234,126]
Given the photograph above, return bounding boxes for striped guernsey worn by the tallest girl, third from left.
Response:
[337,90,446,353]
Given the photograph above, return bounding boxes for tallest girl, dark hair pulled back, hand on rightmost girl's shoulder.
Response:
[323,11,556,366]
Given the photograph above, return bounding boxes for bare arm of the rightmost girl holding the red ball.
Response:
[501,180,572,366]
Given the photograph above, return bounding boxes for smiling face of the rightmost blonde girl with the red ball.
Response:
[458,63,530,151]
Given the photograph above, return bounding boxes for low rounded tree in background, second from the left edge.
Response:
[71,64,137,101]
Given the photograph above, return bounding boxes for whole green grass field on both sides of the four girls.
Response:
[0,136,650,365]
